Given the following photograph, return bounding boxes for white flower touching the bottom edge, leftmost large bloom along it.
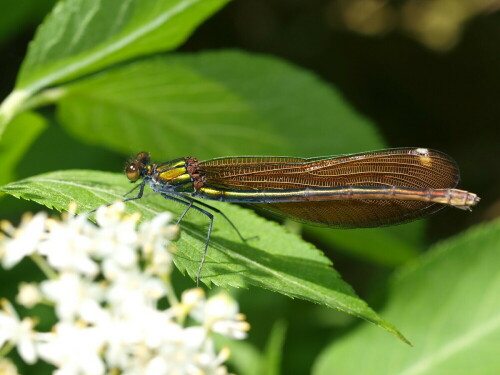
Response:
[38,323,106,375]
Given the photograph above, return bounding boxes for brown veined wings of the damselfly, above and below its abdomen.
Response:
[200,148,459,228]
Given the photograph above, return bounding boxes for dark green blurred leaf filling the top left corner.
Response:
[0,0,56,44]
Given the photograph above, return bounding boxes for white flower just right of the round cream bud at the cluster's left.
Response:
[40,272,104,322]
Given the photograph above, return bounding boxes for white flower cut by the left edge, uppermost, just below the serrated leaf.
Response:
[0,212,47,269]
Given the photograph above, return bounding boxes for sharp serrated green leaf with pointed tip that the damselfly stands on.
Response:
[1,170,404,340]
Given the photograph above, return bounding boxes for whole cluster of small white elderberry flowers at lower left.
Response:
[0,203,249,375]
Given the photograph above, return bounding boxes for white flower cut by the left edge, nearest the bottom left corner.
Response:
[0,300,37,364]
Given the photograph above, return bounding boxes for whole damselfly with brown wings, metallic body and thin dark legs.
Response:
[121,148,479,284]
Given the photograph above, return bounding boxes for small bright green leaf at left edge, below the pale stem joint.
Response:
[0,112,47,185]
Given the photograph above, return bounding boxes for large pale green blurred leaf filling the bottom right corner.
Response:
[314,220,500,375]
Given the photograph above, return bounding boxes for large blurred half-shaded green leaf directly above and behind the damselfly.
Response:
[55,51,382,159]
